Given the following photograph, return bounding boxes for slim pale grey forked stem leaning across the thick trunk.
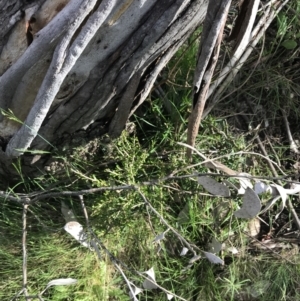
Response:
[6,0,116,157]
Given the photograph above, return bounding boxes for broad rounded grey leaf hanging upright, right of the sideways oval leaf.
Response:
[234,188,261,218]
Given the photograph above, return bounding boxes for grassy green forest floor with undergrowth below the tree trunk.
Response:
[0,2,300,301]
